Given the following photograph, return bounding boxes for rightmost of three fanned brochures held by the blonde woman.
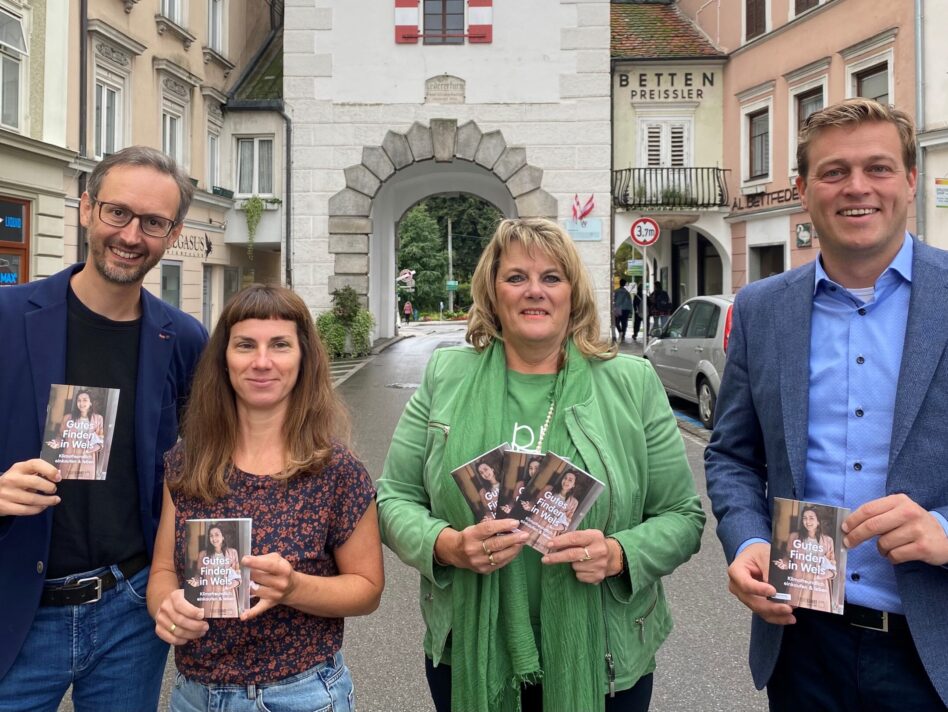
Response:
[520,452,604,554]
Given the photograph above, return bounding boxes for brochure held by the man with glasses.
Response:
[40,383,119,480]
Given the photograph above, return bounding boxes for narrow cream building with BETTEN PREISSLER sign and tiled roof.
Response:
[612,0,731,306]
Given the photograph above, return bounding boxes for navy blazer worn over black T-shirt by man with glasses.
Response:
[0,264,207,677]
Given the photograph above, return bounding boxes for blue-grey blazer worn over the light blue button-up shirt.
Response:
[705,242,948,704]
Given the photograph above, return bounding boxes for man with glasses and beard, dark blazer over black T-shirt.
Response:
[0,147,207,711]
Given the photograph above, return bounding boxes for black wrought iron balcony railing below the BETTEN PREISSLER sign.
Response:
[612,168,728,210]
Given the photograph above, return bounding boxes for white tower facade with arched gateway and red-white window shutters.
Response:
[284,0,611,337]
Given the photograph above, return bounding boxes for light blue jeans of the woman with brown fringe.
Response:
[170,652,355,712]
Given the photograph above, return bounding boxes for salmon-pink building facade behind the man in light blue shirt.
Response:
[679,0,920,291]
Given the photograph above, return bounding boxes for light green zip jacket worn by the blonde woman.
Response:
[377,347,705,694]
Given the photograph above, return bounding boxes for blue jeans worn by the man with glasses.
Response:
[0,566,168,712]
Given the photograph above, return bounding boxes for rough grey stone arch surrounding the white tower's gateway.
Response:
[329,119,558,338]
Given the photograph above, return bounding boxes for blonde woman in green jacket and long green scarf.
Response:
[378,219,704,712]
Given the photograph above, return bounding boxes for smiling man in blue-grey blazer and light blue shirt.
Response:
[705,99,948,712]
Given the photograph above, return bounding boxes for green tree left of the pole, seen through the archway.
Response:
[398,203,448,311]
